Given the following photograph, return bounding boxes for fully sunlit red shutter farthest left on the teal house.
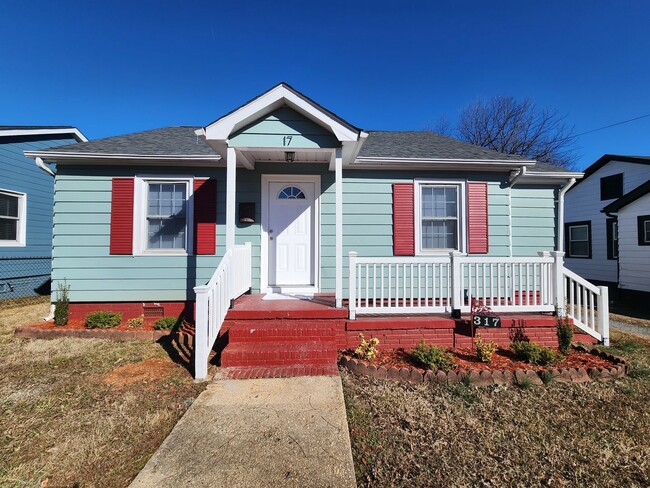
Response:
[110,178,134,254]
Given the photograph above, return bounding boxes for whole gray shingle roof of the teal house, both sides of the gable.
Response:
[31,126,566,172]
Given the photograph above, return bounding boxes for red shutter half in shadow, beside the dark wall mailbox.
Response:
[194,179,217,254]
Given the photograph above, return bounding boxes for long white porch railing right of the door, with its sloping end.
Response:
[348,252,609,342]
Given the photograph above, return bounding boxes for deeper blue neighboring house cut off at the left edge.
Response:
[0,126,87,301]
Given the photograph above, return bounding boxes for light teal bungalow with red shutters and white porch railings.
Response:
[26,83,606,376]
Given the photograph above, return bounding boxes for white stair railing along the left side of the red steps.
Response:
[194,242,251,379]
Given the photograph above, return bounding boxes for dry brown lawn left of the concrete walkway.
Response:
[0,303,204,487]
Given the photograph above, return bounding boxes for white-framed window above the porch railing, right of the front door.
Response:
[414,180,466,254]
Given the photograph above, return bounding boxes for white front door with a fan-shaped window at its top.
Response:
[267,180,316,287]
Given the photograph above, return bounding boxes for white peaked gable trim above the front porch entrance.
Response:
[204,85,359,142]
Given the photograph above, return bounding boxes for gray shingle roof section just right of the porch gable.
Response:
[359,131,527,161]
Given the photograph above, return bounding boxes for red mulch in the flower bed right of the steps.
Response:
[343,349,612,372]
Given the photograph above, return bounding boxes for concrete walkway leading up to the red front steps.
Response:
[131,376,356,488]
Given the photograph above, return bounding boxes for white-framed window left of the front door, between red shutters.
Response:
[133,176,194,255]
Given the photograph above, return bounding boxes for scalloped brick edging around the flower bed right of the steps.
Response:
[339,346,629,386]
